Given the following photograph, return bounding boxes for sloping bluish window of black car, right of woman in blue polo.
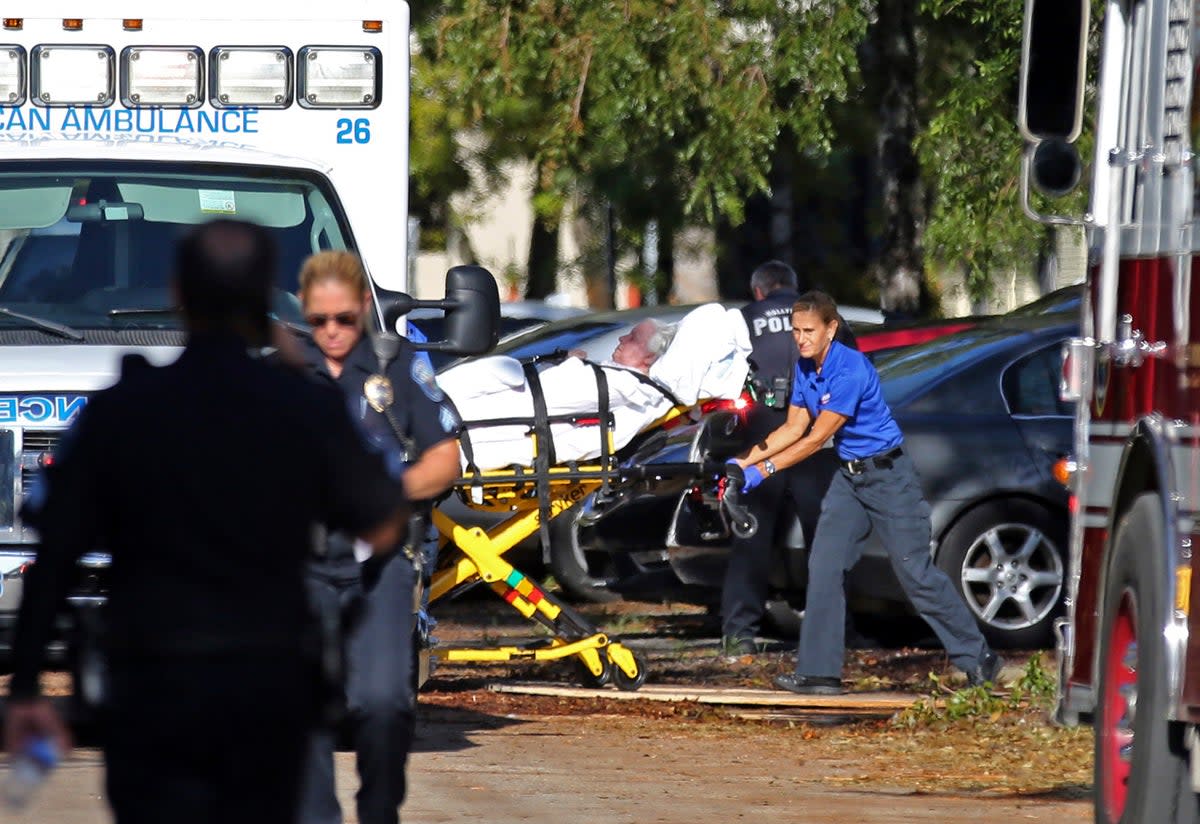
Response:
[875,326,1012,408]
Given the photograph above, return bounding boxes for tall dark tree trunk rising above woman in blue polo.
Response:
[869,0,928,314]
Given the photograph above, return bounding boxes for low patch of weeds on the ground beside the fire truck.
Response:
[893,652,1056,728]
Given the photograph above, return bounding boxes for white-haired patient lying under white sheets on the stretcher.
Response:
[438,303,750,470]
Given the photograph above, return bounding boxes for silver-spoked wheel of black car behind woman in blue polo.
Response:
[937,500,1067,649]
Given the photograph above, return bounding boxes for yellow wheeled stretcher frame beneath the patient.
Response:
[430,371,755,690]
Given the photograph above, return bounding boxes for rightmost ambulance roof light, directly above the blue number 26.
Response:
[296,46,383,109]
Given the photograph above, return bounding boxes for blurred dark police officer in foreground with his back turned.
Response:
[6,221,407,824]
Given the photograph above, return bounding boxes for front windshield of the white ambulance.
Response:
[0,162,353,332]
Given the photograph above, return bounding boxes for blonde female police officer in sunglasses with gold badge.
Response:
[300,251,460,824]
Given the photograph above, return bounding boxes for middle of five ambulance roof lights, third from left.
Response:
[121,46,204,109]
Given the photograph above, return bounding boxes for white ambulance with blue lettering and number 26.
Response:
[0,0,436,657]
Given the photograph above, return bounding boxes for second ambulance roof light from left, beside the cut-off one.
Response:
[29,44,116,107]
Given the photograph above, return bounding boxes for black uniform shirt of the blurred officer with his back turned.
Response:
[11,335,403,696]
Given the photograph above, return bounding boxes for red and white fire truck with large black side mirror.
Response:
[1019,0,1200,824]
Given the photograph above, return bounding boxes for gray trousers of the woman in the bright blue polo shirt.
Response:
[796,455,988,678]
